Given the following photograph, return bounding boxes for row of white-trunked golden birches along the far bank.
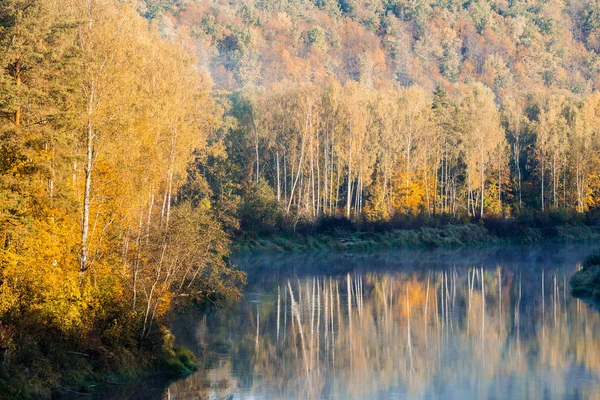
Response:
[218,81,600,231]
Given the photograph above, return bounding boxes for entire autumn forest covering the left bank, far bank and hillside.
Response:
[0,0,600,397]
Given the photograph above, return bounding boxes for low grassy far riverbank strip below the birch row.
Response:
[232,224,600,254]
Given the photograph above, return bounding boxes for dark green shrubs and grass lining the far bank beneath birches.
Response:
[232,216,600,253]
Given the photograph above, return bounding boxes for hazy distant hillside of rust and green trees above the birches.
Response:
[150,0,600,97]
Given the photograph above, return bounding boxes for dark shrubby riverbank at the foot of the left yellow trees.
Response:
[0,329,198,399]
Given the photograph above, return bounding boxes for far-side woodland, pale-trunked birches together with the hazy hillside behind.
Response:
[155,0,600,228]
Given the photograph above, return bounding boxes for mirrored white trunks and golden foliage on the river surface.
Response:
[166,267,600,398]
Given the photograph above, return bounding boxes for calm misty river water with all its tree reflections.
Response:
[92,245,600,399]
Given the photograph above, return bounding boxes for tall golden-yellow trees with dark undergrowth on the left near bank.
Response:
[0,0,244,398]
